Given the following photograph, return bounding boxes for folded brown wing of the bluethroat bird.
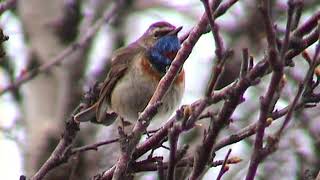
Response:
[96,43,144,125]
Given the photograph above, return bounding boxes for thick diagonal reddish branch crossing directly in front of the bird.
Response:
[109,0,241,180]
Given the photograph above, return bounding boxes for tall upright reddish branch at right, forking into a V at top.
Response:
[246,0,294,180]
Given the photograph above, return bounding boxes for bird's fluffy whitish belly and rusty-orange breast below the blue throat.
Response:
[111,56,184,121]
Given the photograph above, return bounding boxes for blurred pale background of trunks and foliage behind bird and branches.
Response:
[0,0,320,180]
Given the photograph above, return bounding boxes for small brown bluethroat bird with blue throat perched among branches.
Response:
[74,22,184,125]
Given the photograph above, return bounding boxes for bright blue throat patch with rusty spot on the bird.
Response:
[149,35,181,74]
